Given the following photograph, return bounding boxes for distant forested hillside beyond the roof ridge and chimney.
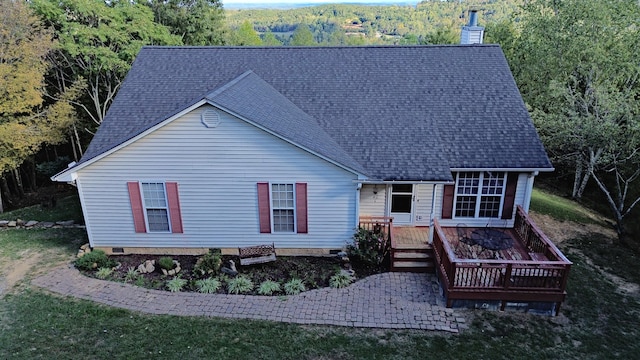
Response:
[226,0,523,45]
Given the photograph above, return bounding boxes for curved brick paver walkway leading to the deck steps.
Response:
[32,266,466,333]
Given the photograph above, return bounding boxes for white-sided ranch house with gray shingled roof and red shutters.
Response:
[53,45,553,254]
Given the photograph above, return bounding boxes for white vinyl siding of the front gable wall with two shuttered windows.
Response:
[78,106,357,249]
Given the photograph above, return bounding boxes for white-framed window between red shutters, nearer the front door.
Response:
[271,184,296,233]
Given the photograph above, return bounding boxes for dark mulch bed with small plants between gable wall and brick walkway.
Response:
[85,255,388,295]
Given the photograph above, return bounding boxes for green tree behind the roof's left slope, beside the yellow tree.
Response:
[32,0,181,127]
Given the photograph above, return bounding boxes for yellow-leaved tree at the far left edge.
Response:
[0,0,75,210]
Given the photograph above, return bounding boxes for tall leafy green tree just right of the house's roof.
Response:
[510,0,638,198]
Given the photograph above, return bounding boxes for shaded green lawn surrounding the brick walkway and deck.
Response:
[0,187,640,360]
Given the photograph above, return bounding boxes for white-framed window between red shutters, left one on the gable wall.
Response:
[141,182,171,232]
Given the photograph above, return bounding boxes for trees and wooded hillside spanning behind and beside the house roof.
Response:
[0,0,640,249]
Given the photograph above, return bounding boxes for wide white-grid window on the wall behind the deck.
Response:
[454,171,507,218]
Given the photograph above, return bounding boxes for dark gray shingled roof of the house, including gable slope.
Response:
[79,45,552,181]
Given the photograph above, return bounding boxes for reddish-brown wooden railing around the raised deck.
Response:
[433,208,571,314]
